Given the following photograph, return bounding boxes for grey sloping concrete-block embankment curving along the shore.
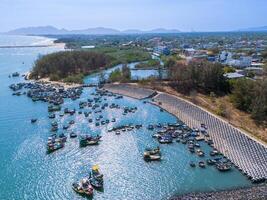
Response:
[104,84,267,182]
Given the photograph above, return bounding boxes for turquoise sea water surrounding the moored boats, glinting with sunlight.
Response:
[0,36,251,200]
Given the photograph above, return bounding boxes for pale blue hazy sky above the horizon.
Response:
[0,0,267,32]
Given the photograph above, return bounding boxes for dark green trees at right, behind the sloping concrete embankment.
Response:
[165,59,267,124]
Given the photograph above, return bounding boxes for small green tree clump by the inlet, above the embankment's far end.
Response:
[109,65,131,82]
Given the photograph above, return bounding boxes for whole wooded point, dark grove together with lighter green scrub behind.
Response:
[30,47,150,83]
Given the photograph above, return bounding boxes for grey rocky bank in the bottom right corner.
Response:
[170,184,267,200]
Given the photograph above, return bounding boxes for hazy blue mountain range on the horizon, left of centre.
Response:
[7,26,180,35]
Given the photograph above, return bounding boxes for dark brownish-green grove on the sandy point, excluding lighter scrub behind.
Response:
[30,51,111,83]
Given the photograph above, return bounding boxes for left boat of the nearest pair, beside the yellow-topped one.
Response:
[72,178,94,196]
